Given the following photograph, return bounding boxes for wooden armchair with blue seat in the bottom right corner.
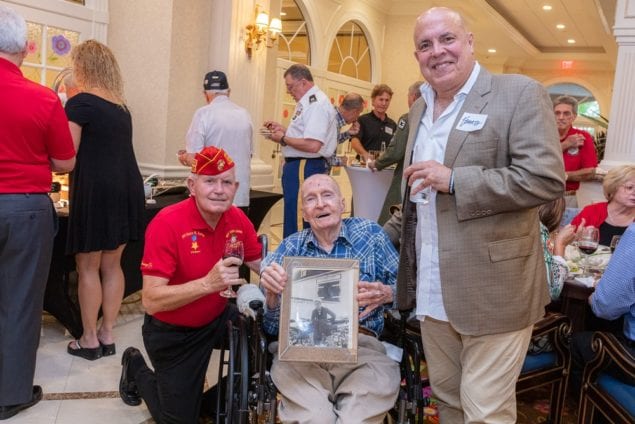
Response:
[578,332,635,424]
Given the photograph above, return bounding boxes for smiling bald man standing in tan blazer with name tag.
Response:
[397,8,564,423]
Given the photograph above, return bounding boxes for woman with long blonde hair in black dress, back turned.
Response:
[66,40,144,360]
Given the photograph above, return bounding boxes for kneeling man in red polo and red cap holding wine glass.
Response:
[119,146,261,423]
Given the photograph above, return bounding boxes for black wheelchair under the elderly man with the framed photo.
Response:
[214,235,428,424]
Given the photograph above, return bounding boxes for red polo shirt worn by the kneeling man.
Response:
[141,197,261,327]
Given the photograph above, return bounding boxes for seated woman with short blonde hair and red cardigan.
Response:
[571,165,635,246]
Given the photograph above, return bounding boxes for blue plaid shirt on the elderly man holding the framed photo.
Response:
[260,218,399,335]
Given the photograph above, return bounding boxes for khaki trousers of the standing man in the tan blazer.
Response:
[421,317,533,424]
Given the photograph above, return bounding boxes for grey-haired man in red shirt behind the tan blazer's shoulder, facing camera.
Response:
[553,96,598,207]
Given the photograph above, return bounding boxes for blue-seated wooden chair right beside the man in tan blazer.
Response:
[516,313,571,424]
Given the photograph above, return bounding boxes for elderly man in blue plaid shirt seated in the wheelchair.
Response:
[260,174,400,424]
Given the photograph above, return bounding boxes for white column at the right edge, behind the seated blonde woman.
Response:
[578,0,635,207]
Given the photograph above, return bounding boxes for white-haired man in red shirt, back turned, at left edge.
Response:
[0,5,75,420]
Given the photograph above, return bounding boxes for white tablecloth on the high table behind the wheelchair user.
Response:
[346,166,394,221]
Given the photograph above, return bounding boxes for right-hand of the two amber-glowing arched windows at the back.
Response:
[328,21,372,81]
